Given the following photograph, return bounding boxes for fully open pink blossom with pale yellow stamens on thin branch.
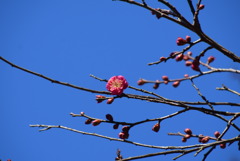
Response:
[106,75,128,95]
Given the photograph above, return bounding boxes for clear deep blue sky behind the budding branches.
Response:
[0,0,240,161]
